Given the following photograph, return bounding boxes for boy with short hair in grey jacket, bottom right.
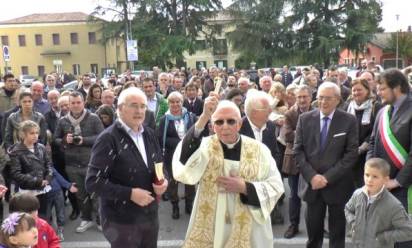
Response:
[345,158,412,248]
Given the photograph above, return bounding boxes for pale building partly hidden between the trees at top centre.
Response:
[184,11,239,69]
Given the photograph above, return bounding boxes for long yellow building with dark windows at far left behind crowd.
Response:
[0,12,126,77]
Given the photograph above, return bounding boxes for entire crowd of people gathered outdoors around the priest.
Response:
[0,62,412,248]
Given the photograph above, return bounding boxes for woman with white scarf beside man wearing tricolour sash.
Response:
[344,78,381,188]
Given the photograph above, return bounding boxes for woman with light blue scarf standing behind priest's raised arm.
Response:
[157,91,197,219]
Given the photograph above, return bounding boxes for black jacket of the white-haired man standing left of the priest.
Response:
[86,121,162,224]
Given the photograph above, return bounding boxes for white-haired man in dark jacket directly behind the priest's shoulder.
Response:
[239,90,283,224]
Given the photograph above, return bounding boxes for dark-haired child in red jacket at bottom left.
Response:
[9,193,61,248]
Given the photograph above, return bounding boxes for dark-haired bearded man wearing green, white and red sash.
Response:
[366,69,412,247]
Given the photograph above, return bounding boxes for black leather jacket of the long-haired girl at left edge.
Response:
[9,143,53,189]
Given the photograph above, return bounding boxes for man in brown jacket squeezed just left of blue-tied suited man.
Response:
[282,85,316,239]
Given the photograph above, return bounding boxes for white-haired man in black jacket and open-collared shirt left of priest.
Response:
[86,87,168,248]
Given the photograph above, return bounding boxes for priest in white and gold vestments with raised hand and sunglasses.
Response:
[173,92,284,248]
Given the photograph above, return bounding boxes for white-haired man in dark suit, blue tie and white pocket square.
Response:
[293,82,358,248]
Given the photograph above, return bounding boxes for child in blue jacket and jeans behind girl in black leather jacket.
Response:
[46,167,77,241]
